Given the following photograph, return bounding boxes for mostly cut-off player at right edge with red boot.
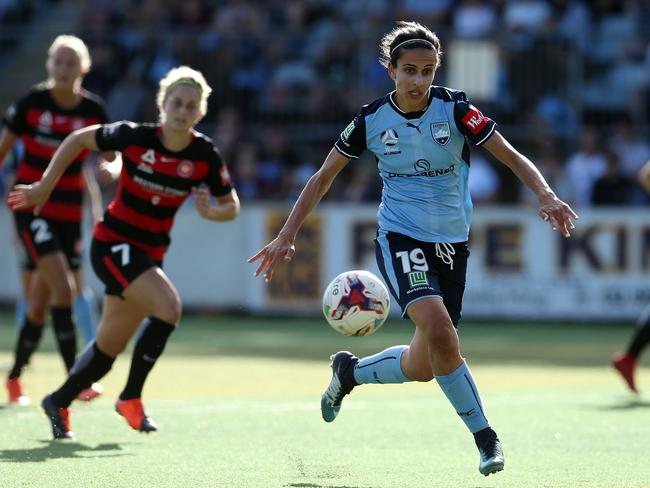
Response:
[612,161,650,393]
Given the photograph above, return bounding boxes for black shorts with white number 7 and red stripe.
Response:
[90,239,162,297]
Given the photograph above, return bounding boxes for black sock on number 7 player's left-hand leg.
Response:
[52,341,115,408]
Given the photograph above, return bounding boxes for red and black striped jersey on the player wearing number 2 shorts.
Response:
[2,84,108,222]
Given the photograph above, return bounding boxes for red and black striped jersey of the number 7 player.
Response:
[93,121,232,261]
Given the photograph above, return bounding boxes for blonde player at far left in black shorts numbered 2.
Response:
[0,36,114,405]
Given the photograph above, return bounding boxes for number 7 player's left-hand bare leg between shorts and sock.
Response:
[95,295,147,357]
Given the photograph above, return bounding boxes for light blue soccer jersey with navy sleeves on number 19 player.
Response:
[335,86,496,242]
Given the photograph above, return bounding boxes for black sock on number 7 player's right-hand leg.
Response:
[120,317,176,400]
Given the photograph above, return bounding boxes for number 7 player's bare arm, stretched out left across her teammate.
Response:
[7,125,100,214]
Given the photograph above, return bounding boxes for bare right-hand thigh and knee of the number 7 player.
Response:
[123,267,182,324]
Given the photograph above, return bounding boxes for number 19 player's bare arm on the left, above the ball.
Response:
[248,148,350,281]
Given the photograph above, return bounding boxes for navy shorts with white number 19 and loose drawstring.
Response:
[375,230,469,327]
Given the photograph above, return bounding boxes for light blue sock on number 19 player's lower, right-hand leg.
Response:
[436,361,490,433]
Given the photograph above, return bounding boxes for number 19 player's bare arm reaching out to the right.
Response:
[483,131,578,237]
